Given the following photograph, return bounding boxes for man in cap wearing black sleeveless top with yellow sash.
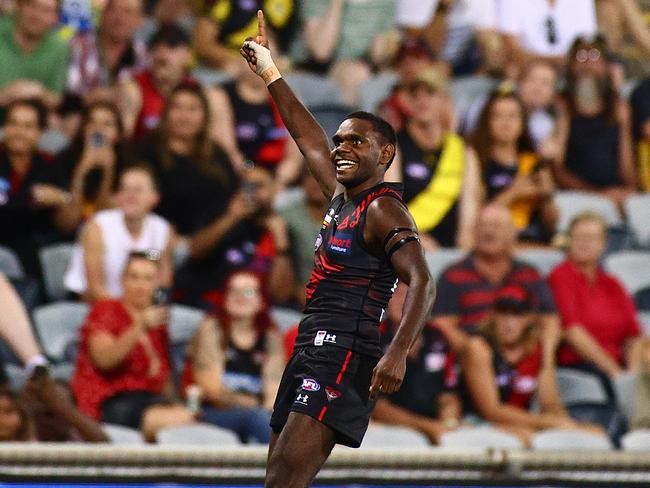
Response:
[386,71,481,251]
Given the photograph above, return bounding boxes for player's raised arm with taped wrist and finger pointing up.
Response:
[240,10,342,199]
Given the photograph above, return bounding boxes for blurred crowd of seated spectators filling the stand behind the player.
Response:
[0,0,650,452]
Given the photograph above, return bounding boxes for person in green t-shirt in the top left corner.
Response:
[0,0,68,107]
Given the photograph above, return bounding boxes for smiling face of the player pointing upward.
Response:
[330,118,395,189]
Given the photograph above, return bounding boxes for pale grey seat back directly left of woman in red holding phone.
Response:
[34,302,88,363]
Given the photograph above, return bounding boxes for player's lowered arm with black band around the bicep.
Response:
[364,197,435,399]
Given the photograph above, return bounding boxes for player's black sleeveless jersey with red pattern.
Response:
[296,183,402,357]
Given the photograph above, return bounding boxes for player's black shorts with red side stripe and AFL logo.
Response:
[271,346,378,447]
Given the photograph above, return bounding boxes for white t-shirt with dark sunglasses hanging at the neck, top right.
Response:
[498,0,598,56]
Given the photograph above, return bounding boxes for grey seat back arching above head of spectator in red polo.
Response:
[554,190,623,232]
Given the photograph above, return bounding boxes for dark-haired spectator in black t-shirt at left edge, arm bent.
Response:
[0,100,81,278]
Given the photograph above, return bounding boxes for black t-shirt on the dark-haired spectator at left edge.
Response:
[0,147,64,277]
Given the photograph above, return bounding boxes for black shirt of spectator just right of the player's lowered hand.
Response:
[381,324,458,418]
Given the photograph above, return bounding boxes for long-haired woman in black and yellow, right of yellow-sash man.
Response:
[472,87,558,244]
